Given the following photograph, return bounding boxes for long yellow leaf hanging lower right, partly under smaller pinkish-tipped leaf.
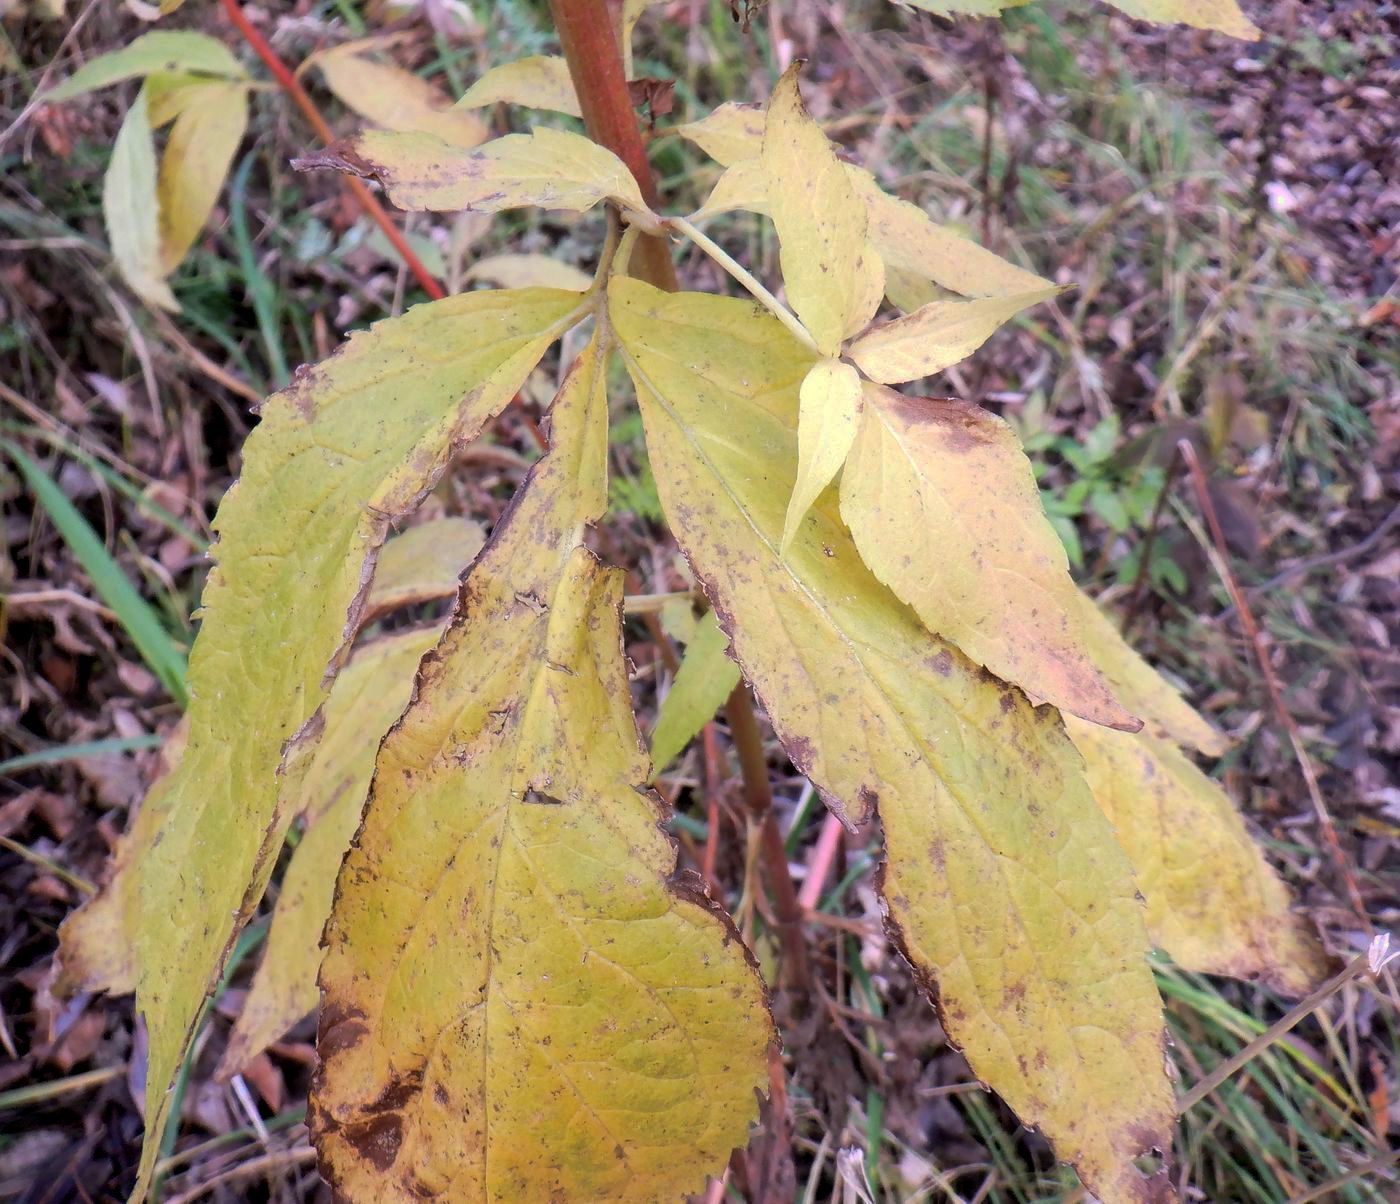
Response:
[610,280,1173,1201]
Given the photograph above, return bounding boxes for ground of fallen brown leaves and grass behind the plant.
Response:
[0,0,1400,1204]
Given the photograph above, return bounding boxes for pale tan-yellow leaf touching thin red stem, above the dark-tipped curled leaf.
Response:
[314,42,487,148]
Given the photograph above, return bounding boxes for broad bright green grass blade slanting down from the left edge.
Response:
[0,440,189,707]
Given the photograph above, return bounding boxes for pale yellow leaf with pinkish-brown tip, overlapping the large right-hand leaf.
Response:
[841,385,1140,729]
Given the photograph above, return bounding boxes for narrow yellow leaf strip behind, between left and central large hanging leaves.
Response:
[220,624,442,1077]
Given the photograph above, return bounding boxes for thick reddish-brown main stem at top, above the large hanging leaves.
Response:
[549,0,678,293]
